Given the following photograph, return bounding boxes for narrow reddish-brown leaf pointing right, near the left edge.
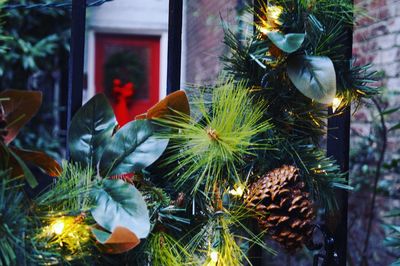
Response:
[11,148,62,177]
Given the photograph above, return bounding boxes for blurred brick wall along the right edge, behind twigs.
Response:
[349,0,400,265]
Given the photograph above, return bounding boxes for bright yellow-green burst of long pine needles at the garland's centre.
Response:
[160,80,271,194]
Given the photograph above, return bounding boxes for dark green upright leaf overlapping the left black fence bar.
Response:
[68,94,117,167]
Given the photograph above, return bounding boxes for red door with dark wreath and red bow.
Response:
[95,34,160,125]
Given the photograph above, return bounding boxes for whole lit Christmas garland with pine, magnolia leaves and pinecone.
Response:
[0,0,378,266]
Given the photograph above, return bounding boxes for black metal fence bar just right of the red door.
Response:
[167,0,183,94]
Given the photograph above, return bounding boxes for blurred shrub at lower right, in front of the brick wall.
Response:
[348,90,400,265]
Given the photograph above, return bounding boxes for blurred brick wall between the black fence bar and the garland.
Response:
[186,0,238,84]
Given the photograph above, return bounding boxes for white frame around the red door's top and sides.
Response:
[83,27,168,102]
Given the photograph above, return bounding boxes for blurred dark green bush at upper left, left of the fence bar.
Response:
[0,0,70,159]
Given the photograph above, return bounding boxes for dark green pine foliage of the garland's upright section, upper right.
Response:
[223,0,379,210]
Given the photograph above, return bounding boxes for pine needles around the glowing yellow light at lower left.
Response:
[31,161,97,264]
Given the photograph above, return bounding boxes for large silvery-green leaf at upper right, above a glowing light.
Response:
[287,55,336,104]
